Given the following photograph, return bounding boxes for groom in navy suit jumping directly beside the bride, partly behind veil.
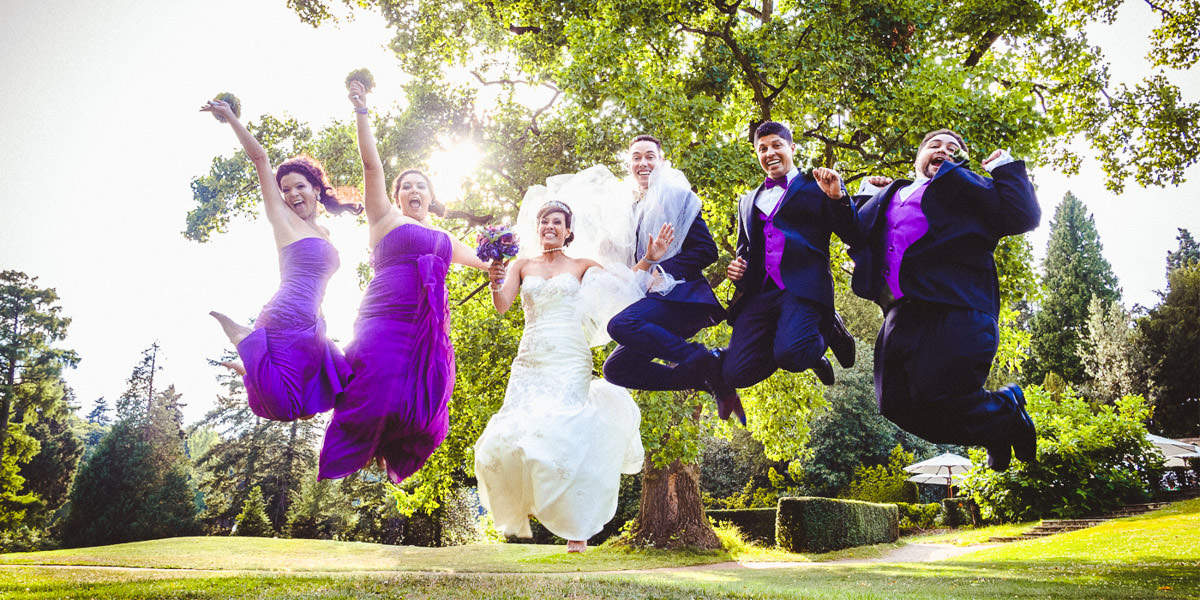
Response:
[604,136,745,425]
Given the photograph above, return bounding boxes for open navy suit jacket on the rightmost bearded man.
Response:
[850,161,1042,319]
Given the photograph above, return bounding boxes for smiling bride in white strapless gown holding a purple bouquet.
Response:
[475,180,674,552]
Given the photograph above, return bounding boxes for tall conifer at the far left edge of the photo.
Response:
[0,271,79,470]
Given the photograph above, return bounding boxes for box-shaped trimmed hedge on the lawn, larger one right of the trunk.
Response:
[775,497,900,552]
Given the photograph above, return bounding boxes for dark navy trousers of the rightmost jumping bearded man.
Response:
[875,299,1020,448]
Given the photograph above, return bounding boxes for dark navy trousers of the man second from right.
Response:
[721,288,830,388]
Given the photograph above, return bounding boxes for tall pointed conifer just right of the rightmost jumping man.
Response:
[1027,192,1121,384]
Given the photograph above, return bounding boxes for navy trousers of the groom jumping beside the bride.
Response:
[604,296,713,391]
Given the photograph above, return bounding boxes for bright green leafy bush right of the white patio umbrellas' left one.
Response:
[960,385,1163,522]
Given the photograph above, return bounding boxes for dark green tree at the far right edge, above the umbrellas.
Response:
[1138,262,1200,437]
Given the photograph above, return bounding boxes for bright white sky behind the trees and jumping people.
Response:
[0,0,1200,421]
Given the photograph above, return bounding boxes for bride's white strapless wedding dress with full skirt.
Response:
[475,269,643,540]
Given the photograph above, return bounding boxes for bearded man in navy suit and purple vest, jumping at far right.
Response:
[851,130,1042,470]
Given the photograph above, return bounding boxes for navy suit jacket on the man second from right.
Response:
[730,173,862,323]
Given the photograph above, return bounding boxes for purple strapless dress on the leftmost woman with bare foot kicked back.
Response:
[238,238,350,421]
